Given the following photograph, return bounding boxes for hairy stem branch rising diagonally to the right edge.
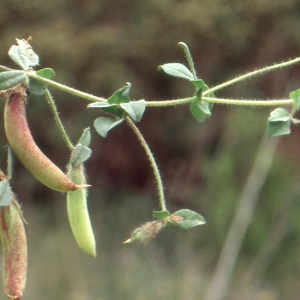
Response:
[203,57,300,96]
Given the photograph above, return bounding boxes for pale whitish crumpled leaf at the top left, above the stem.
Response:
[8,39,39,71]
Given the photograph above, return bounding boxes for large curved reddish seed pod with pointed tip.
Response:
[4,88,80,192]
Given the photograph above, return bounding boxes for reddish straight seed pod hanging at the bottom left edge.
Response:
[0,195,27,300]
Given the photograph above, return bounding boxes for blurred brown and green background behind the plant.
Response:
[0,0,300,300]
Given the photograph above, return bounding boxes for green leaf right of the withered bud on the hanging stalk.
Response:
[170,209,206,229]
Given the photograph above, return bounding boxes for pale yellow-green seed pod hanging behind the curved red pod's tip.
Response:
[67,164,96,257]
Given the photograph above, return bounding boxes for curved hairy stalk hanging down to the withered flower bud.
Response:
[126,117,167,211]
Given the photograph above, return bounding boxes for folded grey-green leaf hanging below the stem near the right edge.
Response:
[268,108,291,137]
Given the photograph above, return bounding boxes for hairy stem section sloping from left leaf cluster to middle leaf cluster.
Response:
[27,71,107,102]
